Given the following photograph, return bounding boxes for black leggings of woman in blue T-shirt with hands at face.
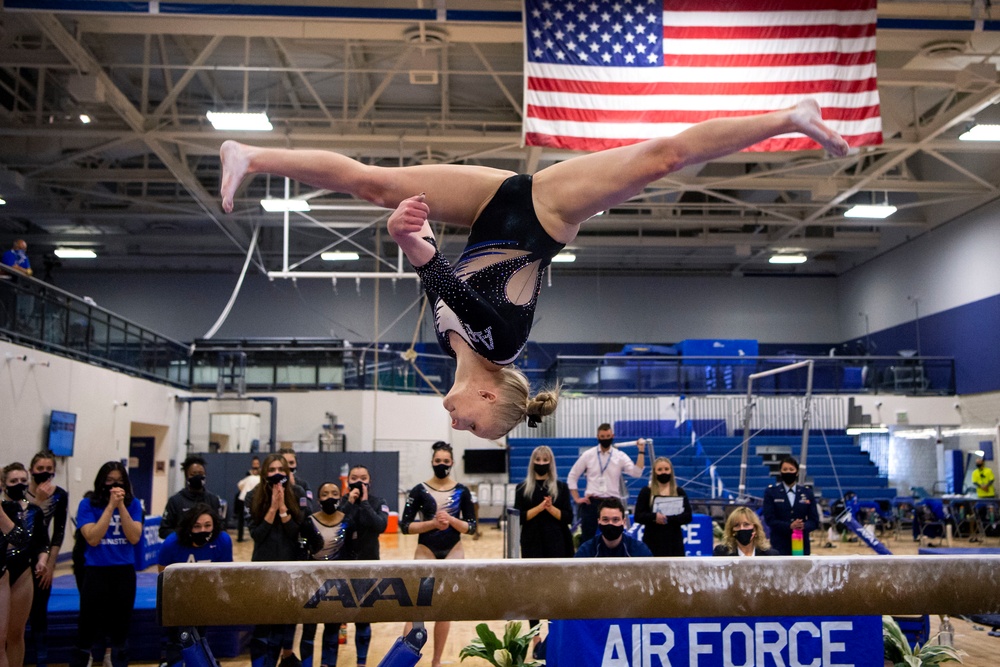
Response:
[76,565,135,656]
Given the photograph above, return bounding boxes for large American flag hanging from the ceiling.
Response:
[523,0,882,151]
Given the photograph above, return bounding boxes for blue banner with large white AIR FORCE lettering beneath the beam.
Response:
[545,616,883,667]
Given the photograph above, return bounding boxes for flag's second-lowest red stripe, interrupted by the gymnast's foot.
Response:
[526,104,879,124]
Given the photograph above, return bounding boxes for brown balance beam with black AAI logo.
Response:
[157,556,1000,626]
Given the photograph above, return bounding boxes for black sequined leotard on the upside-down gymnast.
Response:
[416,175,563,365]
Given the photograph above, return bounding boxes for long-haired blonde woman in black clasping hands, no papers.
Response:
[514,445,573,656]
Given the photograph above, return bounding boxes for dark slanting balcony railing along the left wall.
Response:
[0,267,189,387]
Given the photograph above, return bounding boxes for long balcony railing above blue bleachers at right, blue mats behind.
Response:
[552,356,955,396]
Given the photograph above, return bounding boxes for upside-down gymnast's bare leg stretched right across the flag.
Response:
[536,99,849,243]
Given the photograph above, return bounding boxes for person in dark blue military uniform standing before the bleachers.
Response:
[763,456,819,556]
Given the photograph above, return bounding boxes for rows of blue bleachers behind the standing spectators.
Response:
[509,434,896,502]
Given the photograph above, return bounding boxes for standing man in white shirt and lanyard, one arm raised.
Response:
[566,424,646,542]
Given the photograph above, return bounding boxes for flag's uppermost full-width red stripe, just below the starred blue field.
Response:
[528,76,878,96]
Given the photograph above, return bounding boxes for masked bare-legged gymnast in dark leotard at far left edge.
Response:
[0,463,49,667]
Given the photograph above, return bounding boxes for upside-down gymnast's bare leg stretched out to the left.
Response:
[219,141,513,227]
